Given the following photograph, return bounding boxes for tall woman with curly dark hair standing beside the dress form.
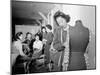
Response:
[53,11,70,71]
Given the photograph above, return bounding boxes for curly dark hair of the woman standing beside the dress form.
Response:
[54,11,70,25]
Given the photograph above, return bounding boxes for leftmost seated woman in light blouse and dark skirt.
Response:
[11,32,30,73]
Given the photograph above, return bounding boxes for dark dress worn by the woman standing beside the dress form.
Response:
[51,27,67,72]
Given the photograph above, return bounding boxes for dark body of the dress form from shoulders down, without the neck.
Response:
[68,26,89,71]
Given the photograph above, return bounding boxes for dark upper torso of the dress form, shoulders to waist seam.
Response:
[69,26,89,53]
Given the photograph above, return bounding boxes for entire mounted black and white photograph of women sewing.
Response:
[10,0,96,75]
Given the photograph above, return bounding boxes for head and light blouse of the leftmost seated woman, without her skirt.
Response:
[11,32,25,65]
